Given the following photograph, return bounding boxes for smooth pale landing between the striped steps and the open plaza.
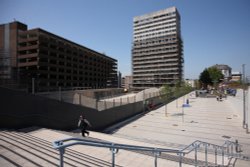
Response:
[28,129,191,167]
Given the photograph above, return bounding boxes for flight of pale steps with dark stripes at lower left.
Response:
[0,130,119,167]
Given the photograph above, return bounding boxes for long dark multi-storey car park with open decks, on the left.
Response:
[0,22,117,90]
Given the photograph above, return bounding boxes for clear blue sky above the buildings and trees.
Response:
[0,0,250,79]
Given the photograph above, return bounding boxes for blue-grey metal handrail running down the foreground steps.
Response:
[53,138,250,167]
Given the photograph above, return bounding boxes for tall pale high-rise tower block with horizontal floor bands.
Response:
[132,7,184,89]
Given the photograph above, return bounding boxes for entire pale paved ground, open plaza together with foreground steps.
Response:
[0,95,250,167]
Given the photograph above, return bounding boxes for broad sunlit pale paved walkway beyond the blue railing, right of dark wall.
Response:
[110,93,250,166]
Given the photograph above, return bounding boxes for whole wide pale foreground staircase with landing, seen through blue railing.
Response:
[0,127,249,167]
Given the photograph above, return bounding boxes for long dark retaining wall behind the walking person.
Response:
[0,88,143,130]
